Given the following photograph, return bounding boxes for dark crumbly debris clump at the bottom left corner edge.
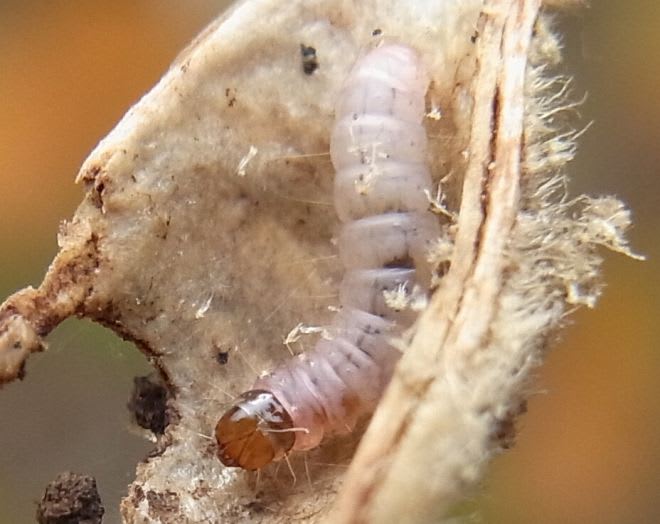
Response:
[37,471,105,524]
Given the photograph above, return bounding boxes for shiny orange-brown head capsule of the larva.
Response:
[215,389,296,470]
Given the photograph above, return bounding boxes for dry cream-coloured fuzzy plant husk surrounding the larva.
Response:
[0,0,631,523]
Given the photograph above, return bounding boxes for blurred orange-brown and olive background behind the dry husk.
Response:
[0,0,660,524]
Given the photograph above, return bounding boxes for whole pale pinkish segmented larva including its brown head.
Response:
[216,44,440,469]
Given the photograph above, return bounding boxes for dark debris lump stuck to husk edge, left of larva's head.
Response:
[127,377,169,435]
